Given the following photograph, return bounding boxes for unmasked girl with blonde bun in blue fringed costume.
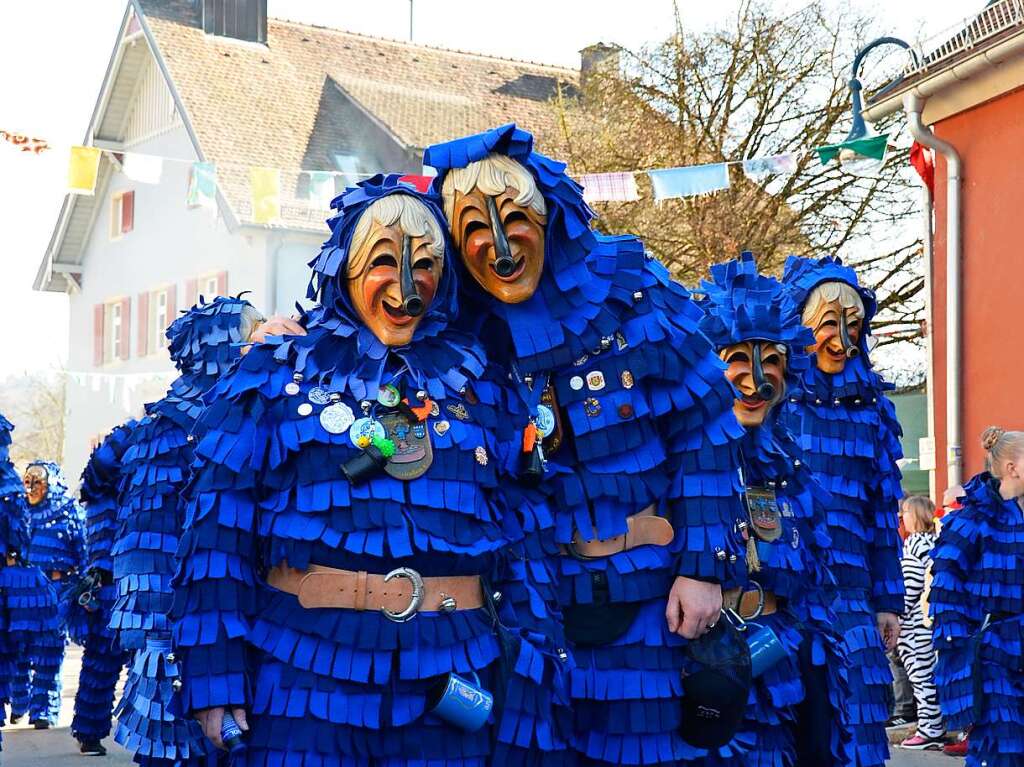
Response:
[931,426,1024,767]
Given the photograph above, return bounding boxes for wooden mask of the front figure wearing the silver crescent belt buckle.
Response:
[346,211,444,346]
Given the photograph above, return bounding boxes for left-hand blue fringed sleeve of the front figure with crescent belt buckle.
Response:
[172,393,262,711]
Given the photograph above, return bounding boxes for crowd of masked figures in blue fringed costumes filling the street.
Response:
[0,125,1011,767]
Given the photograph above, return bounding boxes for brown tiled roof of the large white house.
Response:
[139,0,579,228]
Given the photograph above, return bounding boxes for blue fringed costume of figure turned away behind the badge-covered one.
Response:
[111,296,255,767]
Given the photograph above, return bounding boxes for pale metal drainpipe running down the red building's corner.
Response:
[903,93,964,487]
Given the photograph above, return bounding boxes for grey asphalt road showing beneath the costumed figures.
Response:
[2,645,963,767]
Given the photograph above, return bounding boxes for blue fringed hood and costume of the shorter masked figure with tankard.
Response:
[700,253,854,767]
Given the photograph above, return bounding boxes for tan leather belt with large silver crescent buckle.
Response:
[266,563,485,623]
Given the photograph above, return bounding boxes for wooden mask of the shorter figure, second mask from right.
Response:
[719,341,785,429]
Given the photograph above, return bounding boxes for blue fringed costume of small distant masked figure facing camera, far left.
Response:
[11,461,85,726]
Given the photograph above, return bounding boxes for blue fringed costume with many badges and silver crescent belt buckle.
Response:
[168,177,569,767]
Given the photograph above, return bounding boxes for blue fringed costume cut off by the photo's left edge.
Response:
[0,415,59,745]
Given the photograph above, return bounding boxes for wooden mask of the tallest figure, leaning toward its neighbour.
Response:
[450,186,547,303]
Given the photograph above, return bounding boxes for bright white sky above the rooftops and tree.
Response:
[0,0,984,380]
